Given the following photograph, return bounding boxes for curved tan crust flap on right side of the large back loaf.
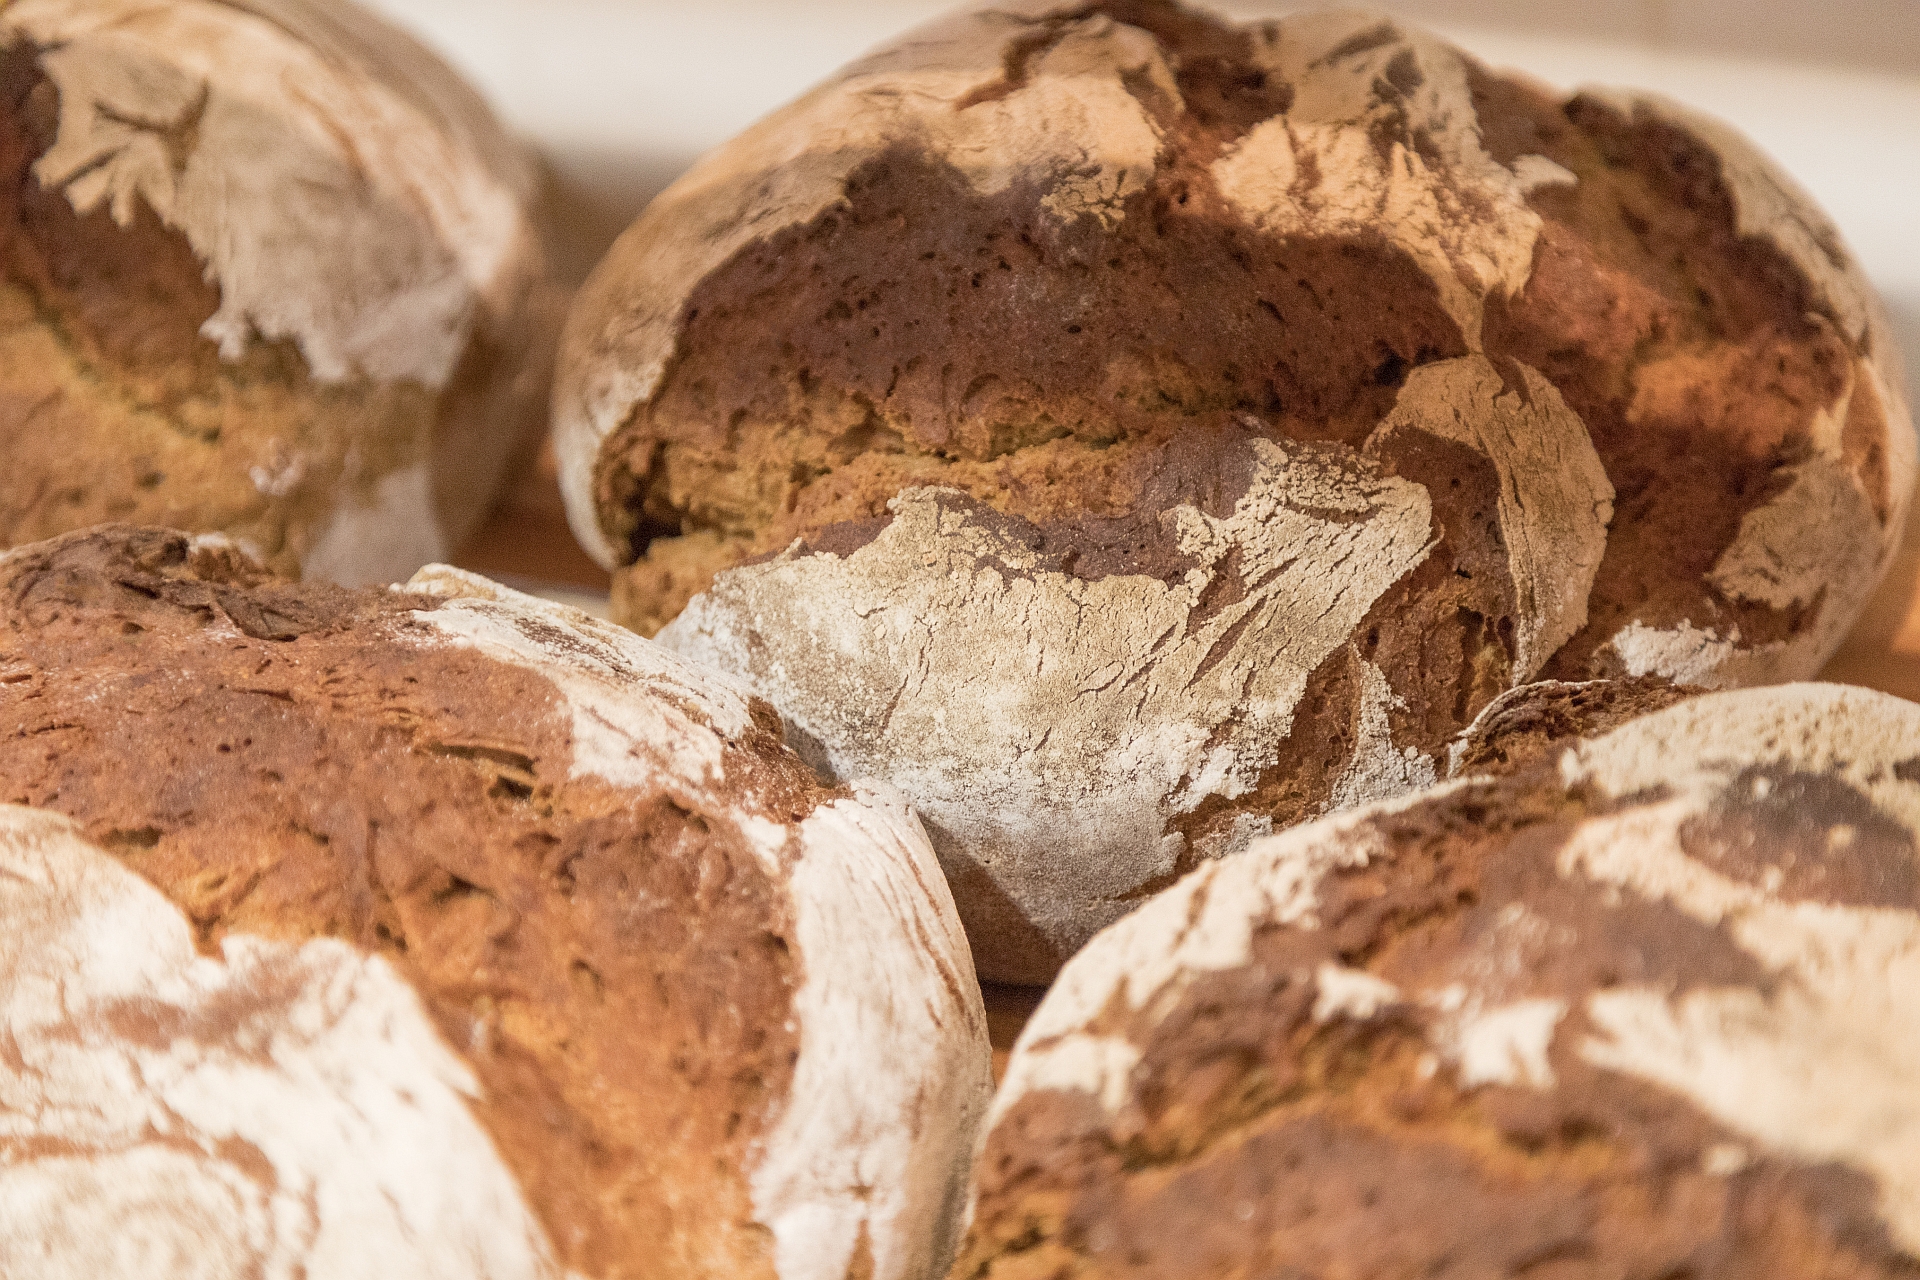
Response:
[1367,355,1613,685]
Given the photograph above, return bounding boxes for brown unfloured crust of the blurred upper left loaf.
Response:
[0,44,559,574]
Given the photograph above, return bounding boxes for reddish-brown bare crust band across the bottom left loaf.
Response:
[0,528,817,1278]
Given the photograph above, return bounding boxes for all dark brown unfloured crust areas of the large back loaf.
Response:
[597,0,1891,702]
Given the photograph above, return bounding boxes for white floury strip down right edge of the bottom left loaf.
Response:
[751,783,993,1280]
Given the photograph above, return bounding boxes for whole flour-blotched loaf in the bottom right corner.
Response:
[954,685,1920,1280]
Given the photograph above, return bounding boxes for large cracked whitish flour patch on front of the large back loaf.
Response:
[660,439,1430,971]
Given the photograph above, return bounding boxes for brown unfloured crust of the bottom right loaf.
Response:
[952,771,1920,1280]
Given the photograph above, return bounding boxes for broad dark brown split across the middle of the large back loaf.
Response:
[599,130,1463,629]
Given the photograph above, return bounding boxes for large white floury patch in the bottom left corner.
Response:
[0,806,559,1280]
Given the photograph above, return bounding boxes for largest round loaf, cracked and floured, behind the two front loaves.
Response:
[555,0,1912,981]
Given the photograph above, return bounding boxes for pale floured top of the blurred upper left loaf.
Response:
[0,0,538,388]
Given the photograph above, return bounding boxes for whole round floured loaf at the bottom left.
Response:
[0,526,991,1280]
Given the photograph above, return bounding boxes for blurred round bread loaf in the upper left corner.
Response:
[0,0,559,583]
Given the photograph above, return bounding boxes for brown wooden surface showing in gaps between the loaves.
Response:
[457,449,1920,1080]
